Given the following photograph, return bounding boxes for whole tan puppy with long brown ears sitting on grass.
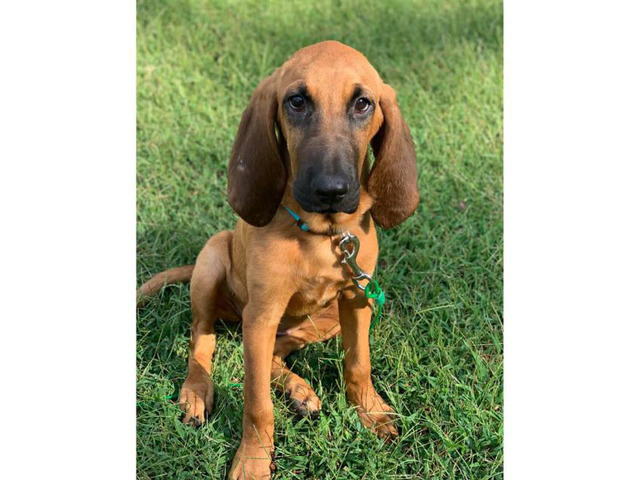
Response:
[139,41,418,479]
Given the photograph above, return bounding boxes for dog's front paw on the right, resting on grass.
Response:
[347,386,398,439]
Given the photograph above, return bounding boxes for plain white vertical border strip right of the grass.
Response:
[505,1,640,480]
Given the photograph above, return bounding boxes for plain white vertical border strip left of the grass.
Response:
[0,1,136,480]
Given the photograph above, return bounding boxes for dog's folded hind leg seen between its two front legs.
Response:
[271,304,340,416]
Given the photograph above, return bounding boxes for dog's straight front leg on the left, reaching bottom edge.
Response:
[229,295,287,480]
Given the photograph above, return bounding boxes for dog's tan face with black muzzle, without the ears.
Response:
[278,48,382,214]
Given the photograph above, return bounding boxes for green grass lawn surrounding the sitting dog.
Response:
[137,0,503,480]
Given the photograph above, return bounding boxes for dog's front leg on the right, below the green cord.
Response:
[338,288,398,437]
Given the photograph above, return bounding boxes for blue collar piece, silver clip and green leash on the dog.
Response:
[283,205,386,332]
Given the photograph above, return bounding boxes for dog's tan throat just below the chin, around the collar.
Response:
[277,182,373,235]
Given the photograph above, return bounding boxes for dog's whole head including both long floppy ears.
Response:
[228,41,418,228]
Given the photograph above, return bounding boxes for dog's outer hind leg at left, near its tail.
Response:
[179,231,233,426]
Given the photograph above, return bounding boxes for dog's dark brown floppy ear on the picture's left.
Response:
[227,73,287,227]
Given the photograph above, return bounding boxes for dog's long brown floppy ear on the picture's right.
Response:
[367,84,419,228]
